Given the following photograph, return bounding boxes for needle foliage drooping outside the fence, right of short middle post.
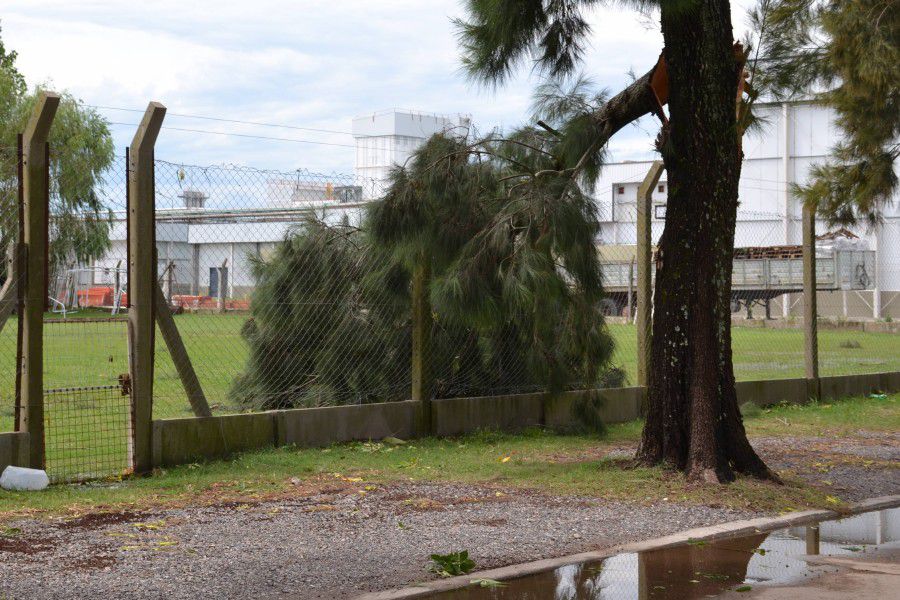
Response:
[422,128,612,391]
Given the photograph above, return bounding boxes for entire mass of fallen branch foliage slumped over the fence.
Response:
[232,130,621,408]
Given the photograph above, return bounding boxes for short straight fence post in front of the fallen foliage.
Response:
[411,259,434,436]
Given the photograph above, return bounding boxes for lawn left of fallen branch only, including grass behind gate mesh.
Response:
[0,311,247,479]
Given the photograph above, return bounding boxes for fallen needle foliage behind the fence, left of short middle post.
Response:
[231,219,410,409]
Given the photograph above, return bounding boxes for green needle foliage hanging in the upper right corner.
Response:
[752,0,900,223]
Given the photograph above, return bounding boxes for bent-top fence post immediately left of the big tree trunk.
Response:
[635,161,665,387]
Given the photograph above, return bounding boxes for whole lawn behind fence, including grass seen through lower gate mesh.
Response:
[0,311,900,477]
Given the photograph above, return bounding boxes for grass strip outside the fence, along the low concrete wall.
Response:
[0,395,900,518]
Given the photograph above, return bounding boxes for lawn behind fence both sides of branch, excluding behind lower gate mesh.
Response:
[0,311,900,431]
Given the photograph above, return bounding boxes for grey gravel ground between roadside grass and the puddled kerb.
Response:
[0,434,900,600]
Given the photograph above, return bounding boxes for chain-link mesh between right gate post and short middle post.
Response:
[154,161,410,418]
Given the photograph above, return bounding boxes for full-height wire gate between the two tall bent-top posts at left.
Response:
[43,152,132,481]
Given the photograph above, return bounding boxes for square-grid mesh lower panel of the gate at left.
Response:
[44,382,132,482]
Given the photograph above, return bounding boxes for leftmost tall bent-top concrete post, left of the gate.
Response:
[19,92,59,469]
